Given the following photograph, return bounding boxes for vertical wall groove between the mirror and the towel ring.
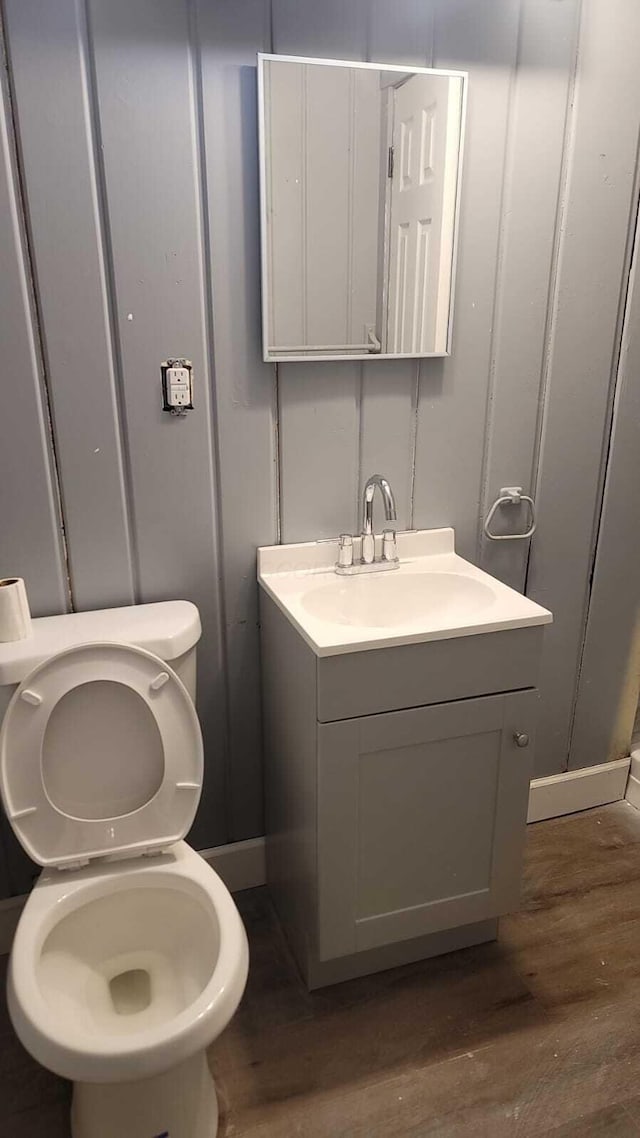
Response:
[476,0,525,560]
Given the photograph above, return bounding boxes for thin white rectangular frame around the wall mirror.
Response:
[257,51,469,363]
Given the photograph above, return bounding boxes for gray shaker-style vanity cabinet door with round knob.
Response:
[318,690,538,959]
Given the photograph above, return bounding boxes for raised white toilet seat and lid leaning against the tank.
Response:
[0,644,203,868]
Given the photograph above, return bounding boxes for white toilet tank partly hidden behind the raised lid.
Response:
[0,601,202,723]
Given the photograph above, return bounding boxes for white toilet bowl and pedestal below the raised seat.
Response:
[8,842,248,1138]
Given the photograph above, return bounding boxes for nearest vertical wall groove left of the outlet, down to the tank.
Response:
[80,0,140,602]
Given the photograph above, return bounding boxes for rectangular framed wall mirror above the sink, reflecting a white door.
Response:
[259,56,466,360]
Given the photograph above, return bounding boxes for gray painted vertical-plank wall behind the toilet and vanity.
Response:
[0,0,640,888]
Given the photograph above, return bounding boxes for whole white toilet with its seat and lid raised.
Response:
[0,601,248,1138]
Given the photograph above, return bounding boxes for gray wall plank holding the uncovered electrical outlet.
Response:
[90,0,228,846]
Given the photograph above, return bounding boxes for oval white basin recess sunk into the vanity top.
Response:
[301,569,494,628]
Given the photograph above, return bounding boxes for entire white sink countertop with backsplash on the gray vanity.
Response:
[257,529,552,657]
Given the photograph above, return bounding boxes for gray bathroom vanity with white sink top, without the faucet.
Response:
[259,529,551,988]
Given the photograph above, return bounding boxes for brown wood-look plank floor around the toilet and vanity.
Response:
[0,802,640,1138]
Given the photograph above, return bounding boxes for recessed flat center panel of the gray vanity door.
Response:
[358,732,500,917]
